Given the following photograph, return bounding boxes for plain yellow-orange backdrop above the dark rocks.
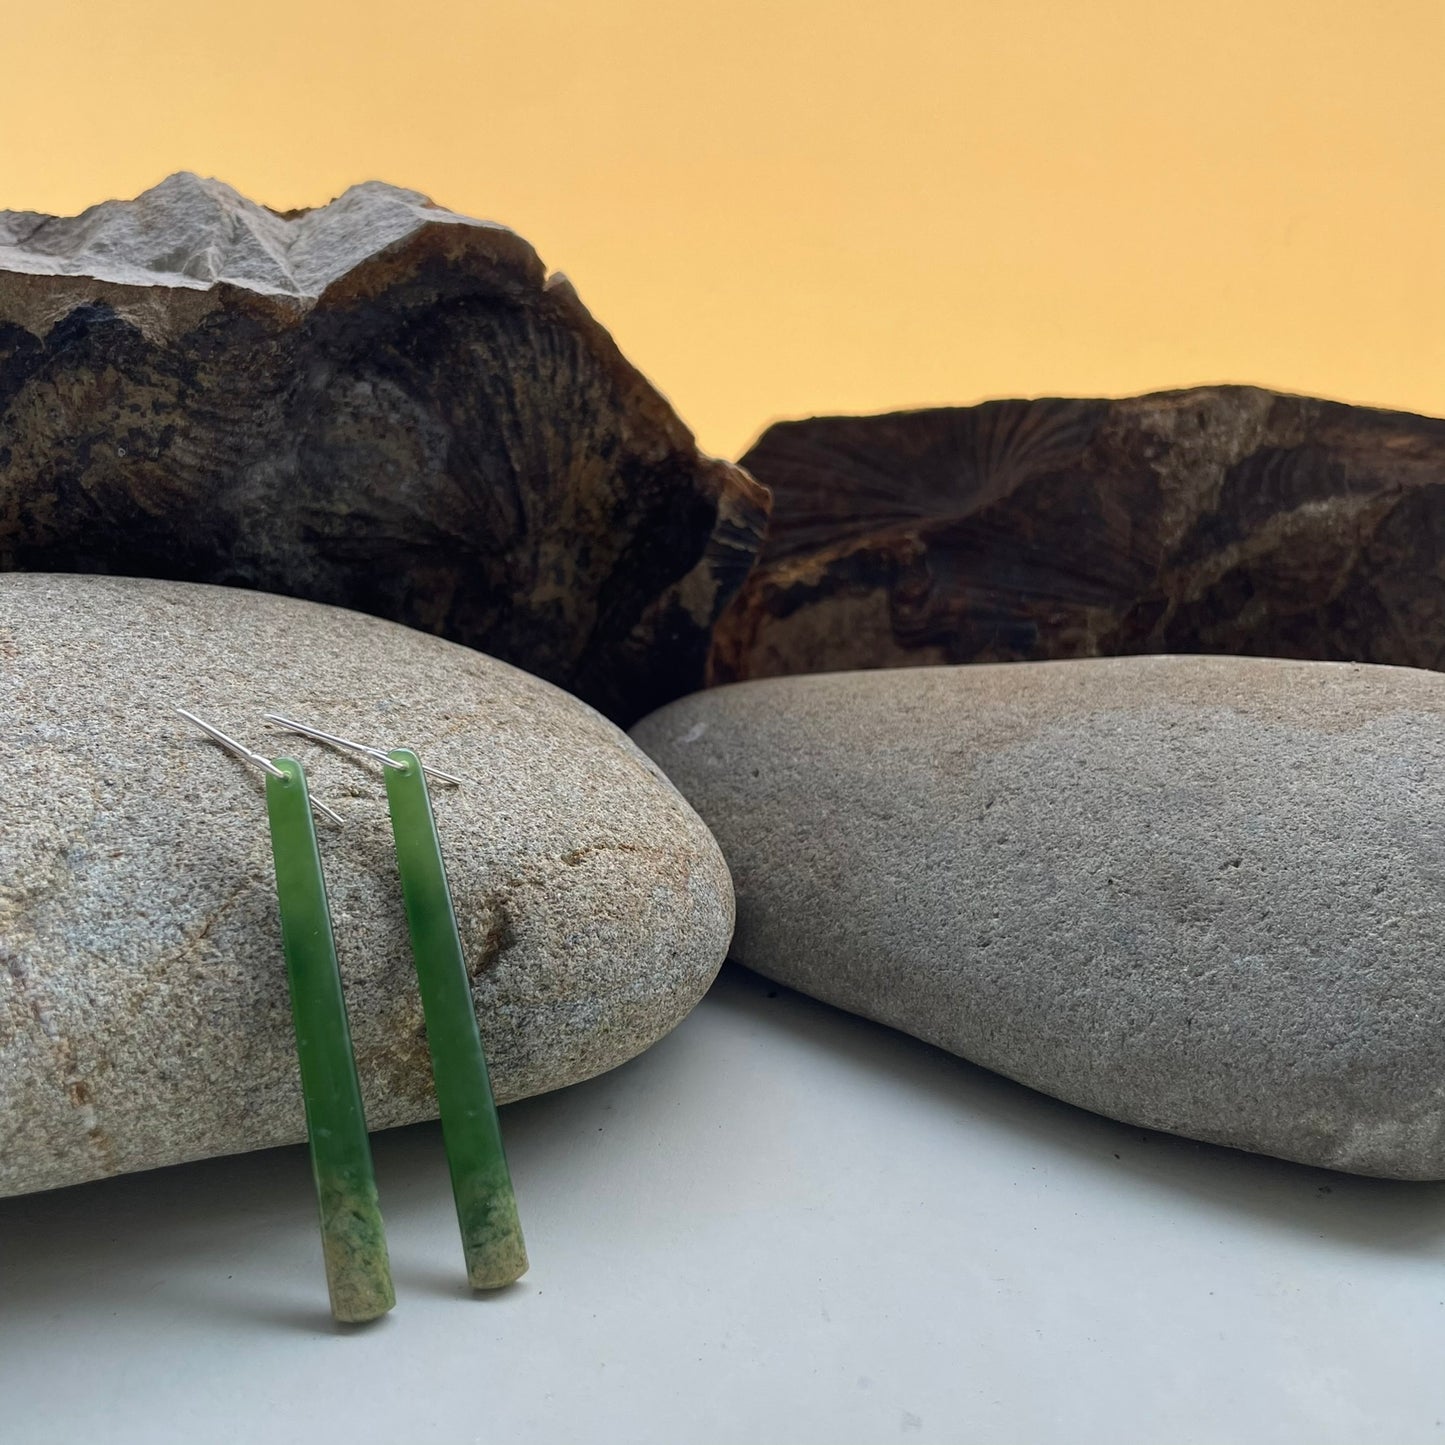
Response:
[0,0,1445,455]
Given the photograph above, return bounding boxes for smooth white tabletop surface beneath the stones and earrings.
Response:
[0,970,1445,1445]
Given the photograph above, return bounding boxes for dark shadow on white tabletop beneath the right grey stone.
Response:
[708,964,1445,1259]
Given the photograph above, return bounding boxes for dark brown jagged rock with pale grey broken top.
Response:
[0,175,767,723]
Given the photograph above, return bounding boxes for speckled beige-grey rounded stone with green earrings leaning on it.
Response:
[0,575,733,1195]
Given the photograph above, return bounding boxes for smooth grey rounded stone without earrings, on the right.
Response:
[633,657,1445,1179]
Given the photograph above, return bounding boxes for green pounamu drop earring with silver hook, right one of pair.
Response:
[266,712,527,1289]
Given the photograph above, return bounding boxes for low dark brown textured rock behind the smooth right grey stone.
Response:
[709,387,1445,682]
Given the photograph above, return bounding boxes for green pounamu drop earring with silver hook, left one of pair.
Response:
[176,708,396,1325]
